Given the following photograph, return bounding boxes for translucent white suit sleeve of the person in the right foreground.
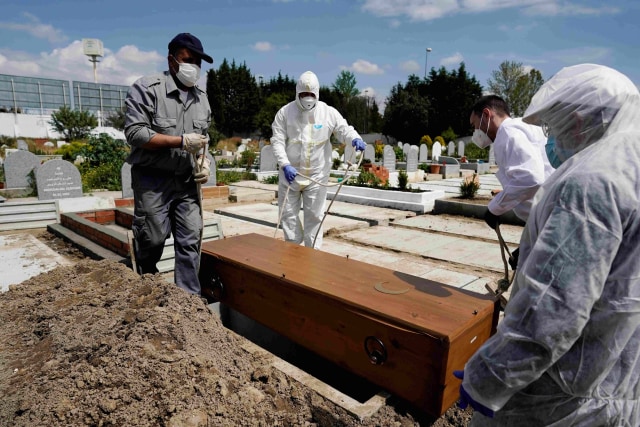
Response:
[463,183,622,411]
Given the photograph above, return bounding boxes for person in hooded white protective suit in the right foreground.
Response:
[454,64,640,427]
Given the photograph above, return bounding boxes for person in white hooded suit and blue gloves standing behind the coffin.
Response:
[271,71,365,249]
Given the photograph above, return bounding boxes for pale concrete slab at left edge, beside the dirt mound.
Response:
[0,233,71,292]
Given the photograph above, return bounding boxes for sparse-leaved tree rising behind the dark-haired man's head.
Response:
[487,61,544,117]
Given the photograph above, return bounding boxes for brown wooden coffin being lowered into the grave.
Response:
[200,234,499,416]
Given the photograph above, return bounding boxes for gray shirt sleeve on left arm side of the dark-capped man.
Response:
[124,80,157,147]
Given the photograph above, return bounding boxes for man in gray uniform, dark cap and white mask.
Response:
[125,33,213,294]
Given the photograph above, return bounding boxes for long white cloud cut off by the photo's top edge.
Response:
[362,0,620,21]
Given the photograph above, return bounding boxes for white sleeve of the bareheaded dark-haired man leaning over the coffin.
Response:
[488,132,544,215]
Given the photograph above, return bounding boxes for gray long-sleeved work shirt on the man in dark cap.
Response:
[124,71,211,175]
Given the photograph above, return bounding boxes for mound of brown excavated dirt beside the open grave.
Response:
[0,232,471,427]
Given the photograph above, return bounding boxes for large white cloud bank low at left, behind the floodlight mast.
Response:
[0,40,165,85]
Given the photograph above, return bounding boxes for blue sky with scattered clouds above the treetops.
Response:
[0,0,640,112]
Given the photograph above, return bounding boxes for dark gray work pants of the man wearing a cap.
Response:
[131,165,202,295]
